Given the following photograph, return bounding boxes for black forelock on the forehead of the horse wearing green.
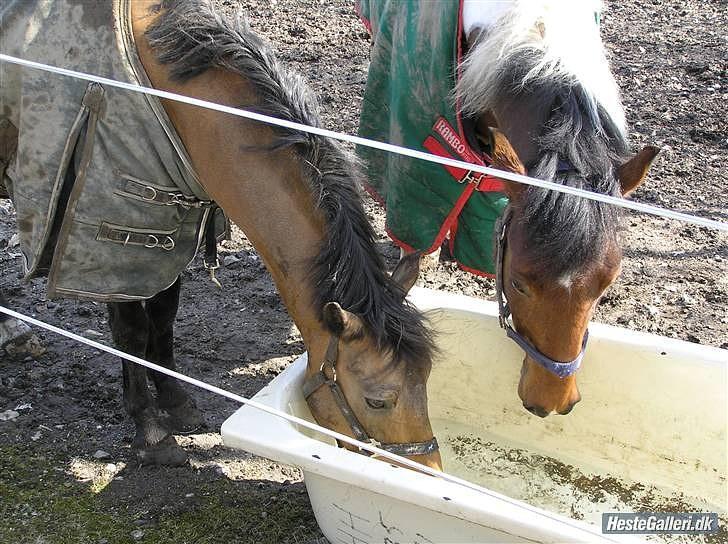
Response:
[517,69,628,279]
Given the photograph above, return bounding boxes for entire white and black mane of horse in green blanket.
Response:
[456,0,628,277]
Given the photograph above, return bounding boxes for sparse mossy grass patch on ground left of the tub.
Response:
[0,446,320,544]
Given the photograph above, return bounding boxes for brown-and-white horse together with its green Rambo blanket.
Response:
[358,0,658,417]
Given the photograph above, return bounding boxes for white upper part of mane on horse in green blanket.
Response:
[457,0,626,136]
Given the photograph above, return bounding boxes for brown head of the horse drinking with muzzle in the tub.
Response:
[303,254,442,469]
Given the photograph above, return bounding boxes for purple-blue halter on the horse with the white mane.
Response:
[495,206,589,379]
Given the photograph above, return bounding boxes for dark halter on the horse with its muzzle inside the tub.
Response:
[303,336,439,456]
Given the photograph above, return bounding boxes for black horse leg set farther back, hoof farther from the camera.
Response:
[144,278,205,434]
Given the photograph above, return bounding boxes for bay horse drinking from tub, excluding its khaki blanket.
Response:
[1,0,441,469]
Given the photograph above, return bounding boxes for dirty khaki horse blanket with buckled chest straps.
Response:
[0,0,220,301]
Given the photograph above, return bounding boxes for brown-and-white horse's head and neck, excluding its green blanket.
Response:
[458,2,658,417]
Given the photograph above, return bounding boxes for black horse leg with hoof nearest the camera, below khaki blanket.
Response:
[108,302,187,465]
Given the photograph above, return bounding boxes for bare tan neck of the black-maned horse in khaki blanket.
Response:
[133,3,325,351]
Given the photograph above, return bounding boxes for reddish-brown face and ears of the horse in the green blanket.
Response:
[490,129,657,417]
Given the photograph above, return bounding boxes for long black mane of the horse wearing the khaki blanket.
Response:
[146,0,434,363]
